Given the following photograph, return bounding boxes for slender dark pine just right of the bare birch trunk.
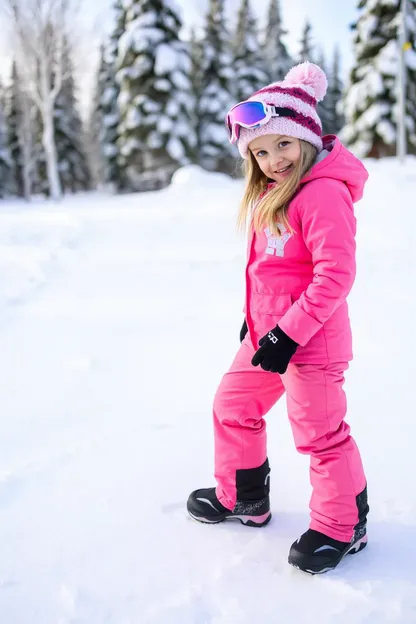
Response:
[54,37,90,193]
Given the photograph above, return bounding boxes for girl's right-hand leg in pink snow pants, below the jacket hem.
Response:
[283,363,368,542]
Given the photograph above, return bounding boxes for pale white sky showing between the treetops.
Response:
[0,0,358,112]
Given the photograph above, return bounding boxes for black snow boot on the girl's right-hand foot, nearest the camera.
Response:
[289,488,369,574]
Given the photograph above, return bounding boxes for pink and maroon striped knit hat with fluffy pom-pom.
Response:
[237,62,328,158]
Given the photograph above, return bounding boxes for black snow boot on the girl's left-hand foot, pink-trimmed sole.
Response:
[187,460,271,527]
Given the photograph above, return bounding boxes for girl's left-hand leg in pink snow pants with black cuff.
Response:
[214,338,284,509]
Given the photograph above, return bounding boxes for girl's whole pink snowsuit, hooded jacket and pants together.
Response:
[214,136,368,542]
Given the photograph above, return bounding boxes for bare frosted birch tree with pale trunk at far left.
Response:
[7,0,75,199]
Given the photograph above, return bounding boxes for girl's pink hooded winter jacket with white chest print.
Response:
[245,136,368,363]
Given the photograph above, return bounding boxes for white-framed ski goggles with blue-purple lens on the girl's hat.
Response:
[226,100,296,143]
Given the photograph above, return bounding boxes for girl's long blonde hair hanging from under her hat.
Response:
[237,140,317,236]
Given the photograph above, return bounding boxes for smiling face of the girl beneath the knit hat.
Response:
[249,134,301,182]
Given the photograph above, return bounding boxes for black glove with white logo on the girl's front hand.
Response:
[251,325,299,375]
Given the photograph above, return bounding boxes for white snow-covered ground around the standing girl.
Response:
[0,159,416,624]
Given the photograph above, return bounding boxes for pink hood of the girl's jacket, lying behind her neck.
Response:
[301,135,368,202]
